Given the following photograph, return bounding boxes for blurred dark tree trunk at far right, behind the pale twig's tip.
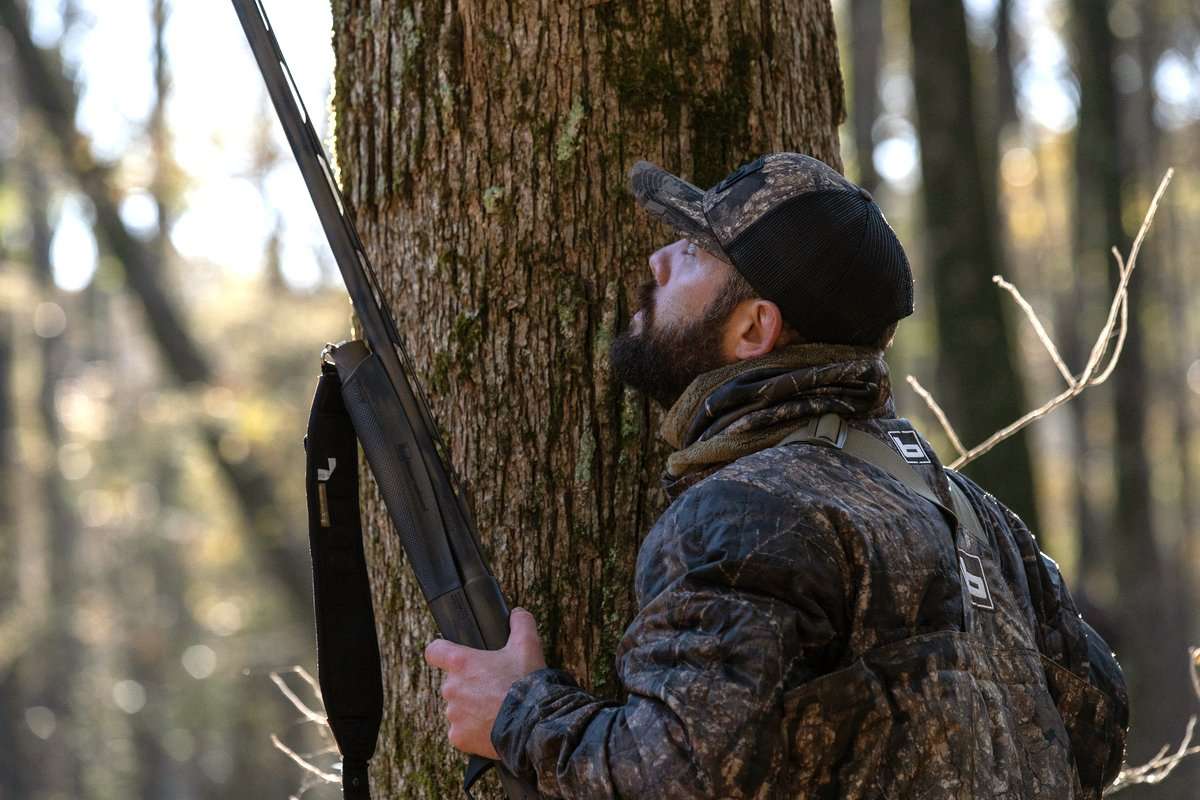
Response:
[1072,0,1194,800]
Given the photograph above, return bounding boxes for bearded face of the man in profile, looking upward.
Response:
[608,239,733,409]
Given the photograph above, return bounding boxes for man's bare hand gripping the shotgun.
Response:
[425,608,546,759]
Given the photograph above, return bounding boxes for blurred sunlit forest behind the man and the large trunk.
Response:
[0,0,1200,799]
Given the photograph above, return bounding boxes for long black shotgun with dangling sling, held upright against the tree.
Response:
[233,0,538,800]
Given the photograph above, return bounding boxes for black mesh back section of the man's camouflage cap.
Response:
[725,188,913,344]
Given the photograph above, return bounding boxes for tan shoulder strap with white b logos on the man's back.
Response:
[779,414,988,631]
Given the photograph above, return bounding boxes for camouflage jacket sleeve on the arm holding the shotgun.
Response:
[492,481,845,799]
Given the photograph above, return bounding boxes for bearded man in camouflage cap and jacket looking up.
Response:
[426,152,1128,800]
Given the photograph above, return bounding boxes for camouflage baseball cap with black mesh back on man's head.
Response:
[629,152,913,344]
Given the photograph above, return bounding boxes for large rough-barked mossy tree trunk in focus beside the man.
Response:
[334,0,844,798]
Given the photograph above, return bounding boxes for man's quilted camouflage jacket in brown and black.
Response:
[492,359,1128,800]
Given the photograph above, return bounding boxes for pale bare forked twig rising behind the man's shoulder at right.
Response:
[908,169,1175,469]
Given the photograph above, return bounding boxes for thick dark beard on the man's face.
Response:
[608,281,730,409]
